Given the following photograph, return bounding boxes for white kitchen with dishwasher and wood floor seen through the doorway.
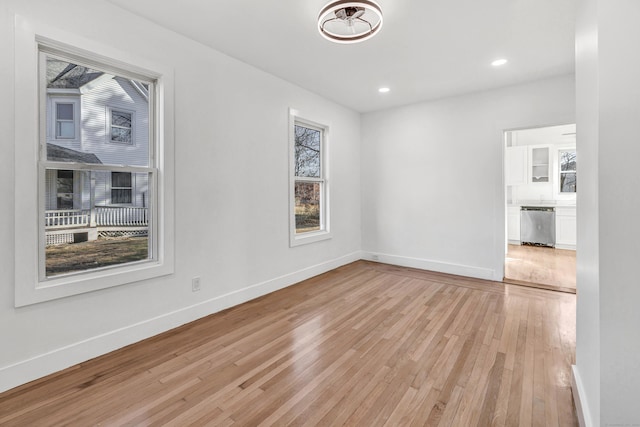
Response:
[504,124,577,293]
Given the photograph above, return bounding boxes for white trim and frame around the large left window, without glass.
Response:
[14,16,175,307]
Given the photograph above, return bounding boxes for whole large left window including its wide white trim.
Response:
[14,23,174,306]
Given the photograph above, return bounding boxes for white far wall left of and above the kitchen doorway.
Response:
[362,76,575,280]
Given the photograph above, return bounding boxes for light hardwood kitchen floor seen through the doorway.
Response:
[504,245,576,293]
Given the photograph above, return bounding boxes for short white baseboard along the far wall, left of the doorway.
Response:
[362,252,502,281]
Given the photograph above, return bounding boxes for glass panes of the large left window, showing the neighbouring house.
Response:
[39,48,157,279]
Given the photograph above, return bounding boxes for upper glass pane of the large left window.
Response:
[41,55,153,167]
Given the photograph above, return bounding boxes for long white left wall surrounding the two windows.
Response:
[0,0,361,391]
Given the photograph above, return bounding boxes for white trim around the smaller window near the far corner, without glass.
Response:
[289,109,332,247]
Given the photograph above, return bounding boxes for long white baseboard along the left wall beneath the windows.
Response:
[0,251,362,393]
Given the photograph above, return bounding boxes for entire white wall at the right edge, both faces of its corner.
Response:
[576,0,640,425]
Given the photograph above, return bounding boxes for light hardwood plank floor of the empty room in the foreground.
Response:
[0,261,577,427]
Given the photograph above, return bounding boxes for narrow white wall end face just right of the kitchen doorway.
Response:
[574,0,600,426]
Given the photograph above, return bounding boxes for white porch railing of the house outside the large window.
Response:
[45,206,149,229]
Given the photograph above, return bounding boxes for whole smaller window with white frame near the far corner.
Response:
[290,116,331,246]
